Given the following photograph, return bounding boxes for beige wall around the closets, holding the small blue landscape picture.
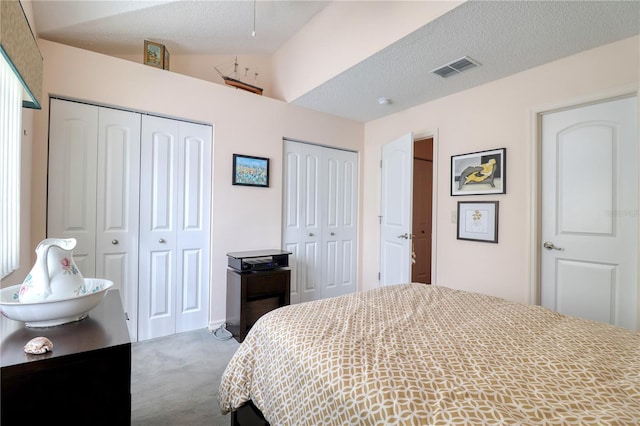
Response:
[16,40,364,324]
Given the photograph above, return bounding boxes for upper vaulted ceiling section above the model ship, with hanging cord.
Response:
[32,0,328,55]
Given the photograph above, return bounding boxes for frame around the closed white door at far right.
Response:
[527,86,640,329]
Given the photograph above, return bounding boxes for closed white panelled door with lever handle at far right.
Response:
[541,97,638,329]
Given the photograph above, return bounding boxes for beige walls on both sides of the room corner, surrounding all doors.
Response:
[10,32,640,330]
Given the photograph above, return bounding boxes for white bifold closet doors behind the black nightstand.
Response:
[283,140,358,303]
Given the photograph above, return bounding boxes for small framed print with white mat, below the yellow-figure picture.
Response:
[457,201,498,243]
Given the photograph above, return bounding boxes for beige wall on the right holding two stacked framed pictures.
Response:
[361,37,640,302]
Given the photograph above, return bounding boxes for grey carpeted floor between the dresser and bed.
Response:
[131,329,239,426]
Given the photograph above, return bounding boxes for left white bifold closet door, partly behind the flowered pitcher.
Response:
[47,99,140,340]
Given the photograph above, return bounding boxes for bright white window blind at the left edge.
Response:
[0,55,22,278]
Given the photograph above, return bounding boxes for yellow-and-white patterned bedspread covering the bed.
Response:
[218,284,640,426]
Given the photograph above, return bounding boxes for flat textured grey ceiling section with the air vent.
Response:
[292,1,640,122]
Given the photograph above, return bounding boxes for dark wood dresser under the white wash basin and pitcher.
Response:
[0,290,131,426]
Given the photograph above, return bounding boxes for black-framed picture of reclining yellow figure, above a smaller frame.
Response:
[451,148,507,195]
